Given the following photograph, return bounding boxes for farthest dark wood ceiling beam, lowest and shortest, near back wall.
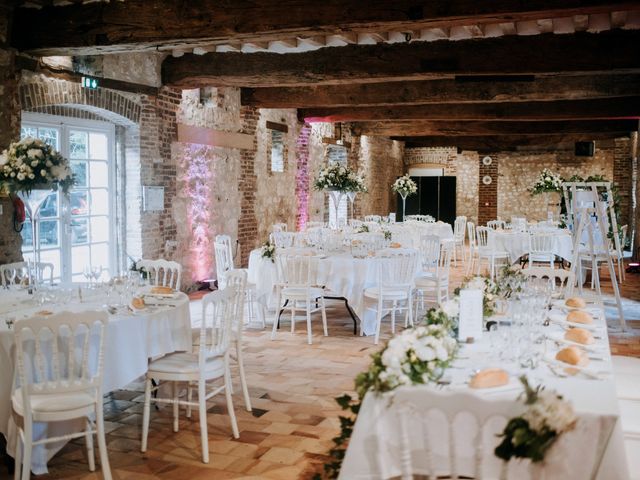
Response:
[400,133,623,152]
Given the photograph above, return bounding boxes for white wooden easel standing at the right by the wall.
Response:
[562,182,627,330]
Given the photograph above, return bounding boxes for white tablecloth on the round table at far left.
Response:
[0,284,191,474]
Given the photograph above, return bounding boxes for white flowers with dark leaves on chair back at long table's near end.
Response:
[495,376,577,463]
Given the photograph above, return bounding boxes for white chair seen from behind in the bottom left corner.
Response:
[11,311,111,480]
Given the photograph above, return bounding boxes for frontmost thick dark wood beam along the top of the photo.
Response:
[13,0,638,55]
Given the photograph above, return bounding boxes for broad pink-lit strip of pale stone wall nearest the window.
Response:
[184,145,213,282]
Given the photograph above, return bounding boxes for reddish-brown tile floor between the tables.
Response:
[0,258,640,480]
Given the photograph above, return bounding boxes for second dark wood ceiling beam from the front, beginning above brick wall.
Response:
[162,30,640,88]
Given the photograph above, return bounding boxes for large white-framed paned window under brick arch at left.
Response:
[20,112,116,282]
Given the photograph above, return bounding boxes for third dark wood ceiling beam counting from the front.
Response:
[241,75,640,108]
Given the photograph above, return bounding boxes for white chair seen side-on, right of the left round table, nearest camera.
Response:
[140,286,240,463]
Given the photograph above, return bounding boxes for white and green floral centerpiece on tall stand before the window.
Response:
[0,138,74,194]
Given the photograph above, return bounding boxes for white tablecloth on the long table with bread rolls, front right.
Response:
[340,304,629,480]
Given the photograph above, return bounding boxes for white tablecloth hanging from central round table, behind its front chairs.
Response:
[248,249,417,335]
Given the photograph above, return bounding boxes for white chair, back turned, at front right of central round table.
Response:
[364,250,417,345]
